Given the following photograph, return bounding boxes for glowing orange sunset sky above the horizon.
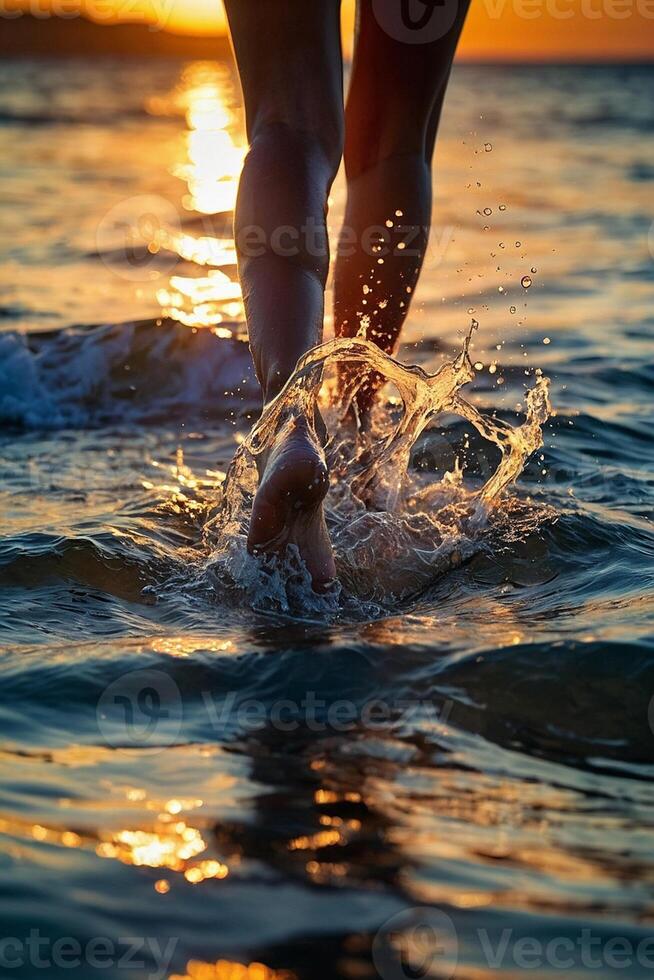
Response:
[15,0,654,60]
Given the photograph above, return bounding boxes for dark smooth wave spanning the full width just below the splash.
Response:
[0,635,654,780]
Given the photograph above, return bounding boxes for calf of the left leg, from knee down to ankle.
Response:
[235,123,340,401]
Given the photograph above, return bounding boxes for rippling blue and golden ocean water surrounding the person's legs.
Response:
[0,59,654,980]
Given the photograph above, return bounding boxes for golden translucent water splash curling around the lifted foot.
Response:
[205,330,551,614]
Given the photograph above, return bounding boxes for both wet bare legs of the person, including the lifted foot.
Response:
[225,0,467,588]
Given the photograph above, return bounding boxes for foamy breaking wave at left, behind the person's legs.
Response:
[0,320,260,429]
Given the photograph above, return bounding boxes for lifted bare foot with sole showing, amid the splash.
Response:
[248,418,336,592]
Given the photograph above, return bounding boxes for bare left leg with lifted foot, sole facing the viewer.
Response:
[225,0,343,588]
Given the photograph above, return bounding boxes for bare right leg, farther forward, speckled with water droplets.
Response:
[334,0,468,416]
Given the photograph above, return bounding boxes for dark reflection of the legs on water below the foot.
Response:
[202,696,410,980]
